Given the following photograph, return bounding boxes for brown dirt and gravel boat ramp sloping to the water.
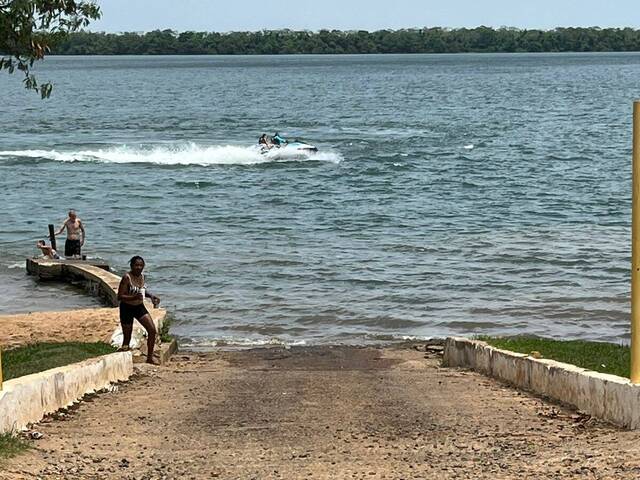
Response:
[0,347,640,480]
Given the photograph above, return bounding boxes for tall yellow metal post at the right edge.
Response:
[631,101,640,383]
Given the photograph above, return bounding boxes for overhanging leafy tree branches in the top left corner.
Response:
[0,0,100,98]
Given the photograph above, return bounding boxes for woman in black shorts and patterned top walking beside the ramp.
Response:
[118,255,160,363]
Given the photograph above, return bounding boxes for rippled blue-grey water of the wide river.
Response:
[0,54,640,346]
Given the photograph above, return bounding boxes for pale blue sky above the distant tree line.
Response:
[90,0,640,32]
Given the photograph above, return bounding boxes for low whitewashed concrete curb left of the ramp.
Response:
[0,352,133,433]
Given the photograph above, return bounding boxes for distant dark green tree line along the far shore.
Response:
[52,27,640,55]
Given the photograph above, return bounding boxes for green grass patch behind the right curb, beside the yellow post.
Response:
[478,337,631,378]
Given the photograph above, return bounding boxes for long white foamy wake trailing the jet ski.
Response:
[0,143,342,166]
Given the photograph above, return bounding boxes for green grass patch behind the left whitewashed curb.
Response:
[2,342,116,380]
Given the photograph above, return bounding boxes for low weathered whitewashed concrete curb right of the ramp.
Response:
[442,338,640,430]
